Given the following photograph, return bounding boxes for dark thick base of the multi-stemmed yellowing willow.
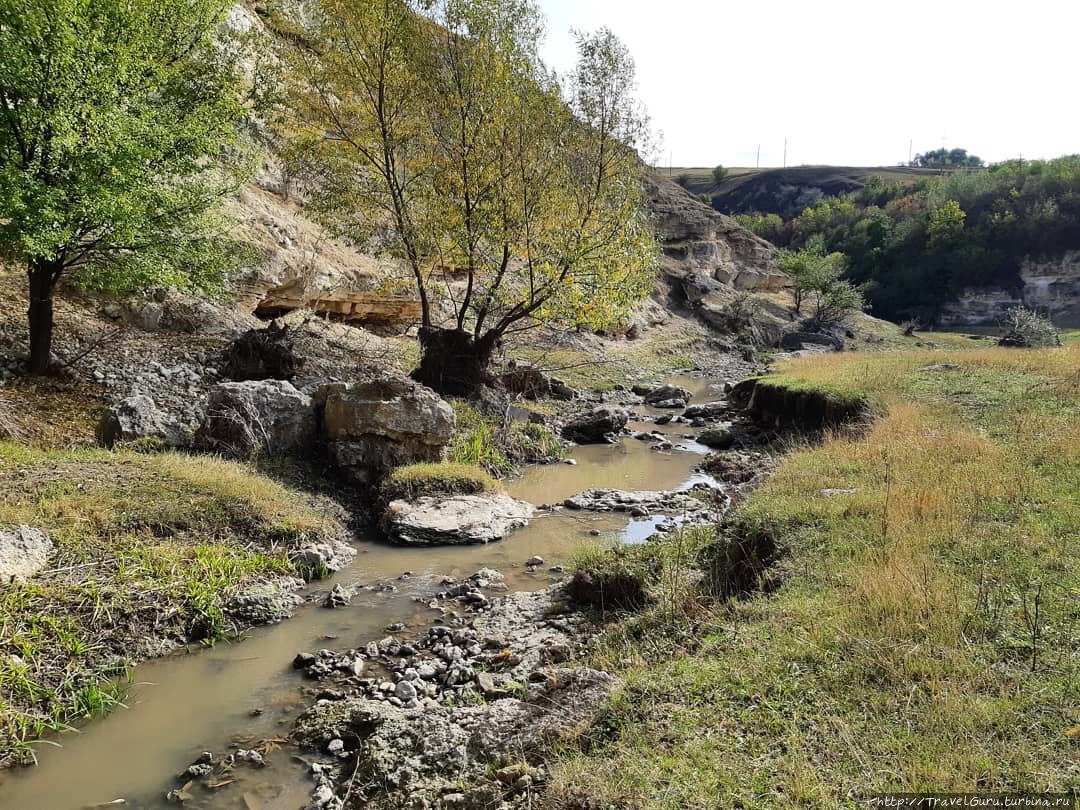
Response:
[413,326,498,396]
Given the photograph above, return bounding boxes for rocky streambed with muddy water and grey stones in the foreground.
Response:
[0,379,777,810]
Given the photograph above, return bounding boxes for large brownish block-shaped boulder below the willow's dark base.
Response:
[315,377,456,482]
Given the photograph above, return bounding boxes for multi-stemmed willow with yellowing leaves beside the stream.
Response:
[286,0,658,393]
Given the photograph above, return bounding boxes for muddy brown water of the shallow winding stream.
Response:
[0,378,713,810]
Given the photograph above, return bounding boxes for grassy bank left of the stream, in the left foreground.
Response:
[0,442,338,765]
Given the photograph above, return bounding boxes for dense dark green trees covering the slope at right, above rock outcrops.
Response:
[735,156,1080,323]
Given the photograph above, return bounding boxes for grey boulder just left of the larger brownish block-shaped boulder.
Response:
[194,380,315,457]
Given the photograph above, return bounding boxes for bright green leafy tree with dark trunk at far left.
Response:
[0,0,242,374]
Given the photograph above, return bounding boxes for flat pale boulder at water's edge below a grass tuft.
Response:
[382,492,534,545]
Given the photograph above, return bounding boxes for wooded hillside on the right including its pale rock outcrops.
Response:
[714,157,1080,327]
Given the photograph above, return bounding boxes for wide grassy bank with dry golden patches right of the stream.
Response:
[548,342,1080,809]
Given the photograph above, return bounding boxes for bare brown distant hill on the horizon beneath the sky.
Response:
[671,166,942,219]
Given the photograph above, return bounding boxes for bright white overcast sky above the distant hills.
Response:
[537,0,1080,166]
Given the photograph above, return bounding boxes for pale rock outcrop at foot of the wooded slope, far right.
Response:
[939,251,1080,328]
